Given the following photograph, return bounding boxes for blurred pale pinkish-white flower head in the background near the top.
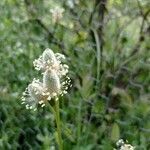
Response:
[50,6,64,23]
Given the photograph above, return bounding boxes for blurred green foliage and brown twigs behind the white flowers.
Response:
[0,0,150,150]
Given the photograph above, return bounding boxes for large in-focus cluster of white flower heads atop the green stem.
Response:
[22,49,71,110]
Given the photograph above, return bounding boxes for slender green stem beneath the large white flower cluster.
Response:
[55,100,63,150]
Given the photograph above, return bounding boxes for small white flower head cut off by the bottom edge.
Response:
[116,139,135,150]
